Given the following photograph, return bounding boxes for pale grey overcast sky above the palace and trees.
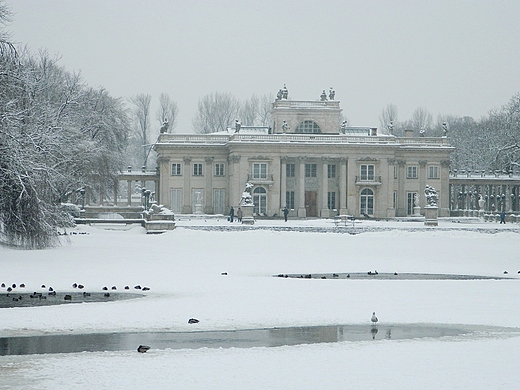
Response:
[8,0,520,132]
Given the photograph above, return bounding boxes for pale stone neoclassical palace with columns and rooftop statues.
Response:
[155,96,453,218]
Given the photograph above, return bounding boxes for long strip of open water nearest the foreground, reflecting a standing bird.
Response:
[0,324,520,355]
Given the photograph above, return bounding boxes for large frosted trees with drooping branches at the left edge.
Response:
[0,6,128,248]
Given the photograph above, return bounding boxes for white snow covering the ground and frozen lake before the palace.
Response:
[0,217,520,389]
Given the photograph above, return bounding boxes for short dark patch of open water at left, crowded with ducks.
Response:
[0,291,144,308]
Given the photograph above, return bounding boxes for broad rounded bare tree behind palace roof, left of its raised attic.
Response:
[192,92,240,134]
